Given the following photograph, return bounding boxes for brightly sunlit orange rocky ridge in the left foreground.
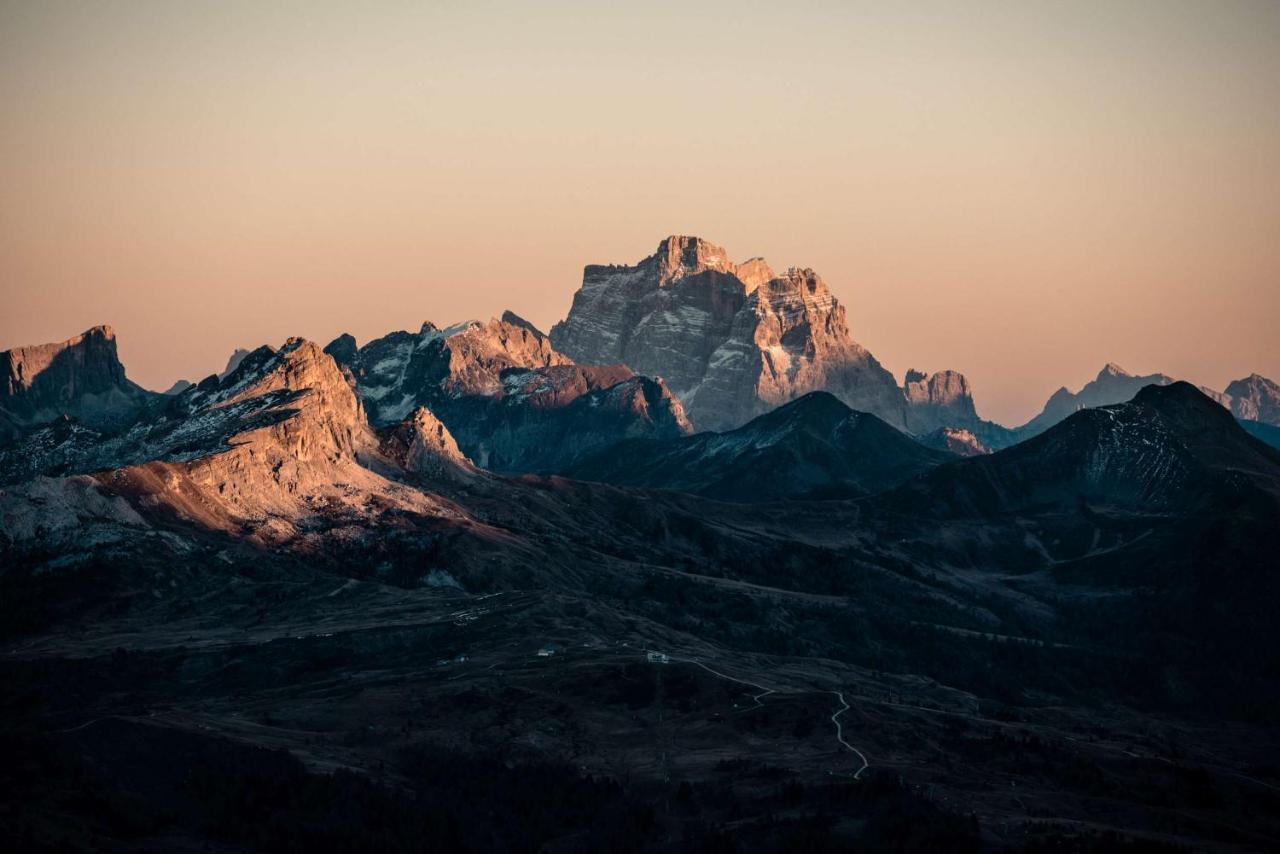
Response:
[0,338,443,542]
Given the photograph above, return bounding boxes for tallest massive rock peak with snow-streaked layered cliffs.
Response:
[550,237,906,429]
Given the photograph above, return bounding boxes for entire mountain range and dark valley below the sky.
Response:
[0,237,1280,851]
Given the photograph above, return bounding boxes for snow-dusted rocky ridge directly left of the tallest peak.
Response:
[325,311,692,472]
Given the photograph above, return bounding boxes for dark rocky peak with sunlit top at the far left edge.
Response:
[0,326,155,440]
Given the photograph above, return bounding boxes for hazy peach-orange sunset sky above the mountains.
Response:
[0,0,1280,423]
